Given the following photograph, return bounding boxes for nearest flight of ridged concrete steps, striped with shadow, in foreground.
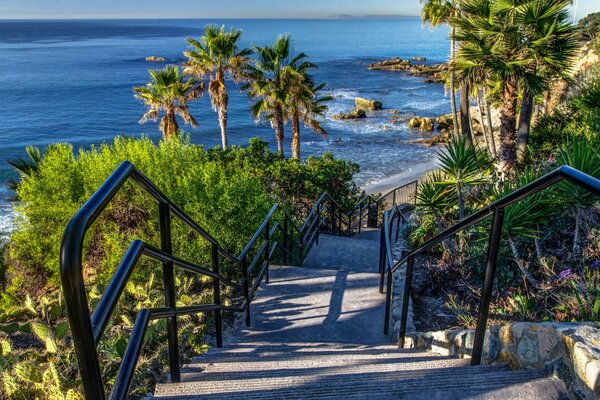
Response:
[155,346,566,400]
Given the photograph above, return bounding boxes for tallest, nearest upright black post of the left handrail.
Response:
[158,202,181,382]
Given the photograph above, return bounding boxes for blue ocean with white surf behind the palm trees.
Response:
[0,19,450,233]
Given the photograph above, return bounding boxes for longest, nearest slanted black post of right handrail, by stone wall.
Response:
[471,208,504,365]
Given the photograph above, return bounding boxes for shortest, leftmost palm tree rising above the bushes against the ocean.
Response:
[133,65,204,139]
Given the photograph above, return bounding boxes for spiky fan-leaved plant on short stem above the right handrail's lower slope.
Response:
[436,137,486,219]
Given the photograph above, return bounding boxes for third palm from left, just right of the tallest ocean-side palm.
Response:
[242,34,306,157]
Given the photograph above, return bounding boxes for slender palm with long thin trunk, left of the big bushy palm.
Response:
[419,0,458,136]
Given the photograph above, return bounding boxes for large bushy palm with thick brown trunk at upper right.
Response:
[451,0,575,172]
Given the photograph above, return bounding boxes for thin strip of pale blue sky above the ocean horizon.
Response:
[0,0,600,19]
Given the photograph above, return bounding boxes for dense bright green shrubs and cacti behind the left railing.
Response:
[0,138,359,399]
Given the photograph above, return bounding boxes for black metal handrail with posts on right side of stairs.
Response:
[380,166,600,365]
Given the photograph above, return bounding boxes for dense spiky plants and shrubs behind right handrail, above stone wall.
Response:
[408,134,600,327]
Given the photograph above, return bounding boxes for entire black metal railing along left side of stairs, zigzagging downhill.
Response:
[60,161,416,400]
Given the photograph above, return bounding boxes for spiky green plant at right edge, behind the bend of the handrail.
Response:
[556,138,600,257]
